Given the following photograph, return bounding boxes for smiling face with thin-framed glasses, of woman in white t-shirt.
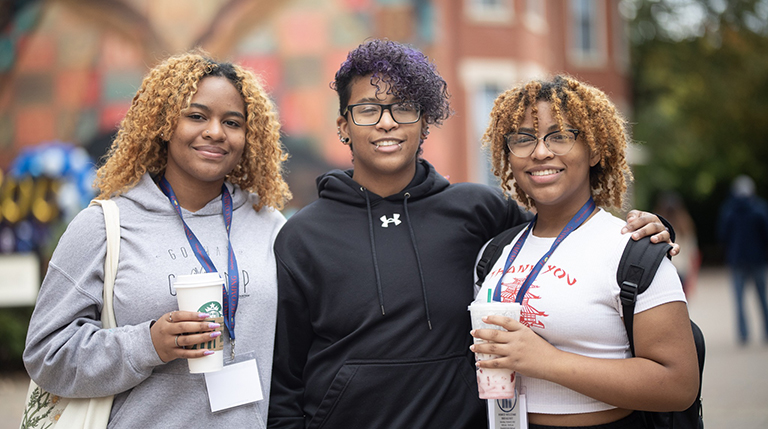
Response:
[508,101,600,215]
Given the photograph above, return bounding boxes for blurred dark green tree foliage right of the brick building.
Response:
[622,0,768,262]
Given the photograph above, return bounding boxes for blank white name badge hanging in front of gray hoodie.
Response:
[205,359,264,413]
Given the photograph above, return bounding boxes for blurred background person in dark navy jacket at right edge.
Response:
[718,175,768,345]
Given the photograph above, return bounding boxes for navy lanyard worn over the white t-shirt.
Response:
[493,197,596,304]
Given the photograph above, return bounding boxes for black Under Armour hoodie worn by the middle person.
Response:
[268,161,529,428]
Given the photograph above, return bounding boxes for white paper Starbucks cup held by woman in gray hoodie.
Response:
[173,273,224,374]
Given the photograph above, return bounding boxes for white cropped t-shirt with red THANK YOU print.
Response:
[476,209,685,414]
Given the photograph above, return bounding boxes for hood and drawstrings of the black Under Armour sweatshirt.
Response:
[317,160,450,330]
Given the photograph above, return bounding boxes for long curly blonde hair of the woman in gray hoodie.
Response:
[94,49,291,210]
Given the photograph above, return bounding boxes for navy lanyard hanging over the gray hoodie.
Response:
[160,176,240,359]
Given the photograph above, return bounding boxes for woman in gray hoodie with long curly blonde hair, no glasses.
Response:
[24,52,290,428]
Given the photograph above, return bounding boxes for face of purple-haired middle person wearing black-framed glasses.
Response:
[336,75,425,197]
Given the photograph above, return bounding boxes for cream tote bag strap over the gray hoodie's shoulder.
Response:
[89,200,120,329]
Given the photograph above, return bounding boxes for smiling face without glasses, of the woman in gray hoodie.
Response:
[165,76,245,193]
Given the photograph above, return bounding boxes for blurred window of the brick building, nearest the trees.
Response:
[569,0,606,66]
